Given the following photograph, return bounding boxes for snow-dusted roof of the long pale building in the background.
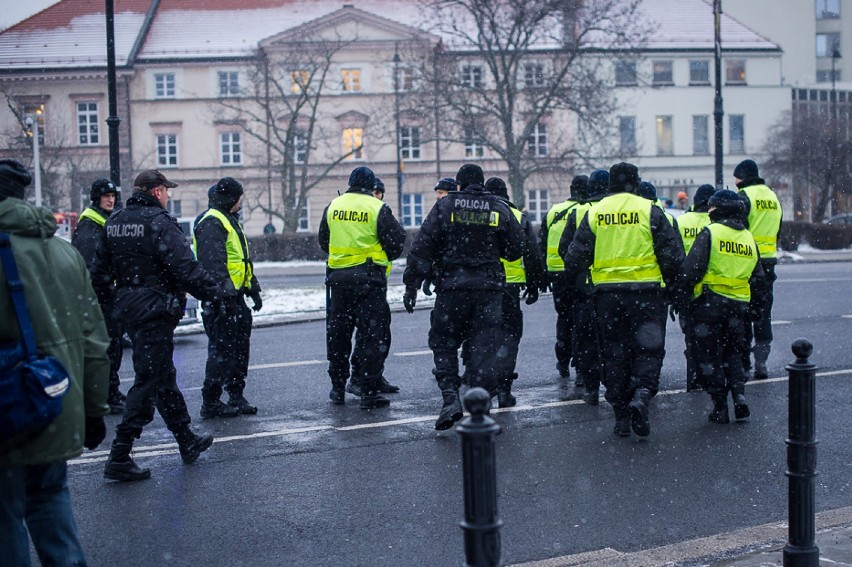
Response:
[0,0,780,72]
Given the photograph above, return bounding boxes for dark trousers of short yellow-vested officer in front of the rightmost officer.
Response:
[691,292,748,397]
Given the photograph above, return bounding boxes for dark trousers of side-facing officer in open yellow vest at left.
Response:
[201,296,252,401]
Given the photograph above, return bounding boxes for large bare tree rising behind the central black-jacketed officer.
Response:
[412,0,653,206]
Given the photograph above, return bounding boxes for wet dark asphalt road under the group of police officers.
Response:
[69,263,852,566]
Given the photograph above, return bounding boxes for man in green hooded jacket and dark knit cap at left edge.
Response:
[0,159,109,565]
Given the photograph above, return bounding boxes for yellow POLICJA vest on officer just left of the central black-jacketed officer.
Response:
[325,193,391,275]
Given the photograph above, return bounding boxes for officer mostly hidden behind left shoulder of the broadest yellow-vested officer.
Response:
[558,169,609,406]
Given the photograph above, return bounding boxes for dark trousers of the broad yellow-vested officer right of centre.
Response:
[595,289,666,408]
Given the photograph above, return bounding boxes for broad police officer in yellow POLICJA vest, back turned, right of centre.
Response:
[565,163,684,436]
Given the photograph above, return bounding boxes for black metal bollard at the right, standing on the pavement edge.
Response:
[784,339,819,567]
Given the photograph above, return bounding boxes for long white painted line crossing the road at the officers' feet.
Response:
[75,368,852,465]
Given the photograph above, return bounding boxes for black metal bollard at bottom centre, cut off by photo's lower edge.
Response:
[457,388,503,567]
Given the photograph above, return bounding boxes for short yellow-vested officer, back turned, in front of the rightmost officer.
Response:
[677,190,767,423]
